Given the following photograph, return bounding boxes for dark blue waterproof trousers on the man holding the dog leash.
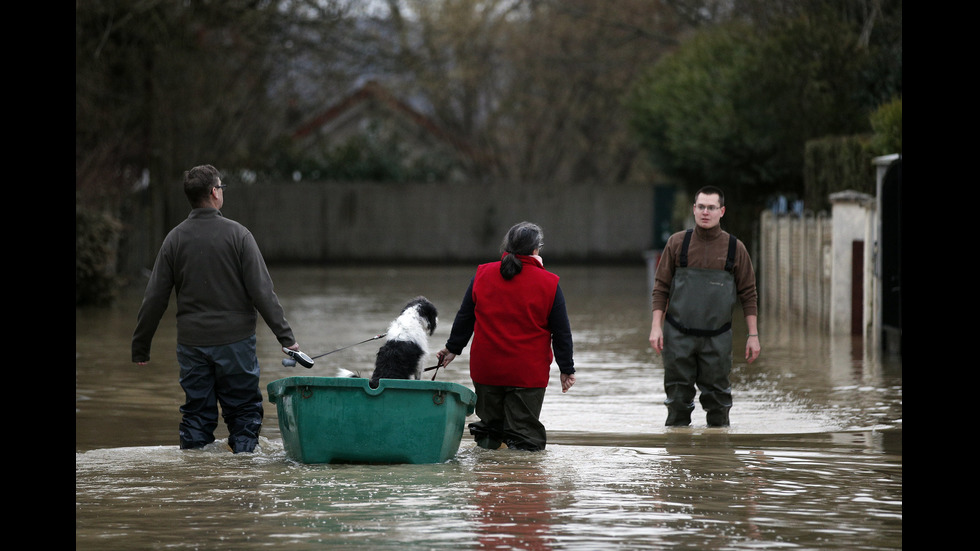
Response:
[177,335,263,453]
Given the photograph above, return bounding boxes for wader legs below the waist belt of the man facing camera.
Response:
[663,323,732,427]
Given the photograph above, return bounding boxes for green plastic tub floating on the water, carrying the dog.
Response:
[268,377,476,463]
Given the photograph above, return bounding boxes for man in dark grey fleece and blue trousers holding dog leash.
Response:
[132,165,299,453]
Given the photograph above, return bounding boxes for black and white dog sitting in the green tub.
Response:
[347,296,439,388]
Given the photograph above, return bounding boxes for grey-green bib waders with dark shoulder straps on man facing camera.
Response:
[663,230,736,427]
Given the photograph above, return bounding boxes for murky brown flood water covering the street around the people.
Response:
[75,266,902,551]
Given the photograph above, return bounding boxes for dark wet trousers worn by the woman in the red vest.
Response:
[470,382,548,451]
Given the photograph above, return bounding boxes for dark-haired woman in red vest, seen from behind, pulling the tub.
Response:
[437,222,575,451]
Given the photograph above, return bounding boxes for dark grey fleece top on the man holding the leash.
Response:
[132,208,296,362]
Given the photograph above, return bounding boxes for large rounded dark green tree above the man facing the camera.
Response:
[630,17,869,203]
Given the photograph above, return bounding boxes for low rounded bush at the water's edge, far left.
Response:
[75,208,122,307]
